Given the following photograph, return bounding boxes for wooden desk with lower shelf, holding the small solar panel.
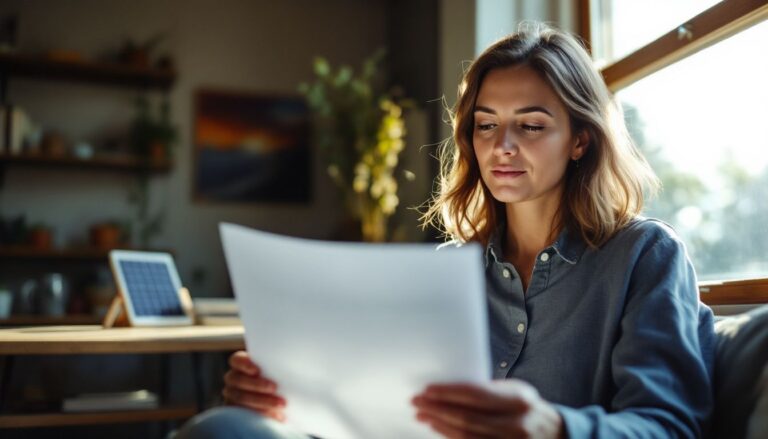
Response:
[0,325,245,428]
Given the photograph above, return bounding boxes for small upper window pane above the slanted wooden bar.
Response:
[593,0,721,63]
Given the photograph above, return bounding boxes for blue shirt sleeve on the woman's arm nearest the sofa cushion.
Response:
[556,236,714,438]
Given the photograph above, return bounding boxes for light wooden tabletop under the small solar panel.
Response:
[0,325,245,355]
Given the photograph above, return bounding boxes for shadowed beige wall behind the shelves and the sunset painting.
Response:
[0,0,385,295]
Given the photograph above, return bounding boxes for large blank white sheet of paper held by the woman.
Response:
[220,224,491,439]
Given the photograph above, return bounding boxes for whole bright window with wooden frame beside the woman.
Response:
[582,0,768,303]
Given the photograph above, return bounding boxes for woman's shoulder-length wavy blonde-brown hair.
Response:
[422,23,659,248]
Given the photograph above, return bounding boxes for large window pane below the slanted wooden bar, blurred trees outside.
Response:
[617,21,768,280]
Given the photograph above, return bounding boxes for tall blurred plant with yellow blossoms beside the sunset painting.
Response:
[299,51,412,242]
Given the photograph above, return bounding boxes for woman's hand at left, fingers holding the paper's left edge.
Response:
[221,351,286,422]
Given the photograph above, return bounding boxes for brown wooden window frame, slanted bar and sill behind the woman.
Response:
[577,0,768,305]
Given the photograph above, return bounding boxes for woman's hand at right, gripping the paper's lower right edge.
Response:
[413,379,564,439]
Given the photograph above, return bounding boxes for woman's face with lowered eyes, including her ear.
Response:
[472,66,586,208]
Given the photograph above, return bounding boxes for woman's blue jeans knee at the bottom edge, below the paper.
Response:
[174,406,312,439]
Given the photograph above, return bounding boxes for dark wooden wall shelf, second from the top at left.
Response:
[0,153,171,173]
